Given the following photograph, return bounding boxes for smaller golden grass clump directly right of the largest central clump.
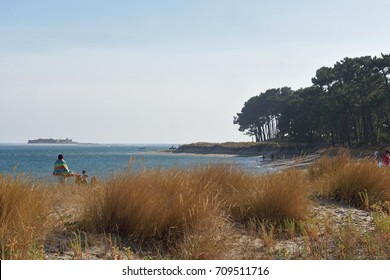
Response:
[230,170,310,230]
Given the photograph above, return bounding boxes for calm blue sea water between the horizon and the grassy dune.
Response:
[0,144,267,181]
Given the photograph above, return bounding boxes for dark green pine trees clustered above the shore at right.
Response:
[233,54,390,146]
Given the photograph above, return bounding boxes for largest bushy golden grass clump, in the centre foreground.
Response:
[81,169,225,258]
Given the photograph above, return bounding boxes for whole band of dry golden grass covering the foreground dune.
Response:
[0,154,390,259]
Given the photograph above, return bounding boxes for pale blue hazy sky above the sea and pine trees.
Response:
[0,0,390,144]
